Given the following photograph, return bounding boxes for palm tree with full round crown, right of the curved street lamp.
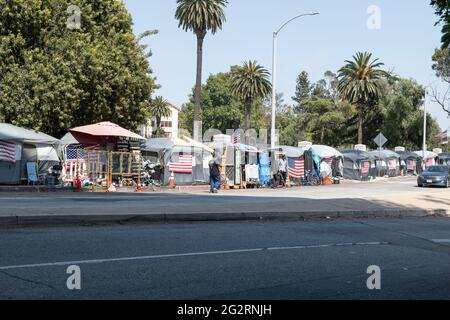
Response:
[338,52,388,144]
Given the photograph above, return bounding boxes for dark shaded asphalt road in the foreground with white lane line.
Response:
[0,218,450,299]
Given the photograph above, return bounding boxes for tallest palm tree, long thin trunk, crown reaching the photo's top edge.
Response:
[175,0,228,136]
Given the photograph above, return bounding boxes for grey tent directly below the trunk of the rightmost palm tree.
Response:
[341,150,375,180]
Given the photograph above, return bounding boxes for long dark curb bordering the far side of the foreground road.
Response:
[0,209,450,228]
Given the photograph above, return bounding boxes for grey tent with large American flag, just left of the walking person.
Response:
[141,138,212,185]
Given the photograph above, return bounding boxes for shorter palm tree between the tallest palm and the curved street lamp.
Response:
[231,61,272,130]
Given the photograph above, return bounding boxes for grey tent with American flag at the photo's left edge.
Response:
[0,123,60,184]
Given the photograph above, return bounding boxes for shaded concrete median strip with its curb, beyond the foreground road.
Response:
[0,189,450,228]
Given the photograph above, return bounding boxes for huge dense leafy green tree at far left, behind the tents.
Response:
[0,0,157,136]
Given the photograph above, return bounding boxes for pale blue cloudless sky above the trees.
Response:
[124,0,450,129]
